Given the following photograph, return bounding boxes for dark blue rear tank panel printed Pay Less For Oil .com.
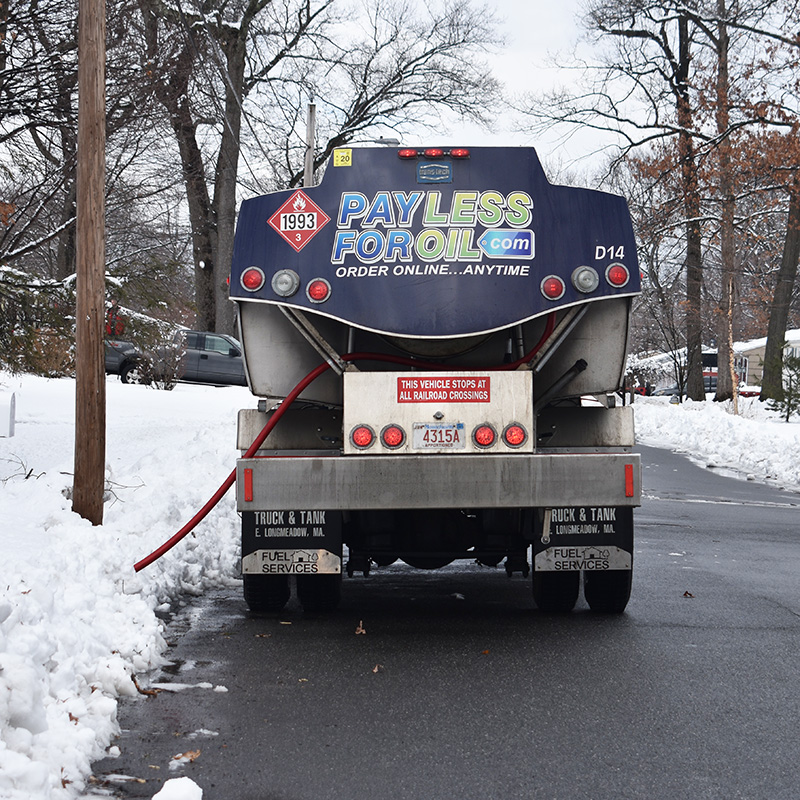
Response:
[230,147,641,338]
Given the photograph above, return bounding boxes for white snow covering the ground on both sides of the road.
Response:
[0,374,800,800]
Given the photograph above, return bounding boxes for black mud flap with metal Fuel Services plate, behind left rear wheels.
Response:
[242,509,342,575]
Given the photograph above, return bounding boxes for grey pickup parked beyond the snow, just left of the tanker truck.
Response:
[150,330,247,388]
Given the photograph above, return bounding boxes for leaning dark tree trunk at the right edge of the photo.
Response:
[760,178,800,400]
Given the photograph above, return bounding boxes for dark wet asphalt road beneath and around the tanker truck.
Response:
[87,448,800,800]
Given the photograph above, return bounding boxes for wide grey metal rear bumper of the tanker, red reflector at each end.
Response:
[236,453,641,511]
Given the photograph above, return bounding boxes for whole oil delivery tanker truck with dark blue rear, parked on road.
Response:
[230,147,641,613]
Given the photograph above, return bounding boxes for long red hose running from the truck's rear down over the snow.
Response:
[133,313,556,572]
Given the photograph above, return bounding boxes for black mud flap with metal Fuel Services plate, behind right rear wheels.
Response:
[533,506,633,572]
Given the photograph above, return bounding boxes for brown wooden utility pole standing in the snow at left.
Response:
[72,0,106,525]
